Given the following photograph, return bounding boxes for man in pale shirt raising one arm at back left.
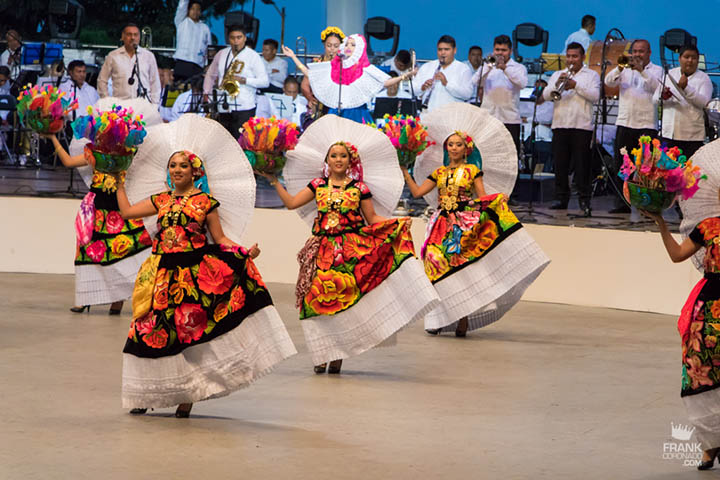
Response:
[173,0,212,81]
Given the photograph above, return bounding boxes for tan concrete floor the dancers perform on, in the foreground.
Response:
[0,273,718,480]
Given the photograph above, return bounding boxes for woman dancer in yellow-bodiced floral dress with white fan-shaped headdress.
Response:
[404,104,550,337]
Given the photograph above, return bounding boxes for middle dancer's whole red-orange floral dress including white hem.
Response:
[296,178,437,365]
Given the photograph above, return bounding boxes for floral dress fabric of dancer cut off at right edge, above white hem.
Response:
[681,217,720,396]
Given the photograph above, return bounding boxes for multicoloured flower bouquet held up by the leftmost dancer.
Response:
[17,85,77,133]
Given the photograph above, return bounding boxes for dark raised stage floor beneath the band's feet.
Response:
[0,166,680,231]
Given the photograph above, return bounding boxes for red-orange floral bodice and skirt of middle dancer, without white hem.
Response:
[300,178,415,319]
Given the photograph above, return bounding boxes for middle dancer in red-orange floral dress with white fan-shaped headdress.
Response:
[267,115,437,373]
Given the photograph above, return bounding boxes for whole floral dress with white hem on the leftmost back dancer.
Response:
[75,171,152,305]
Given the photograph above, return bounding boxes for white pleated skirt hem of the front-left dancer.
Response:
[122,305,297,408]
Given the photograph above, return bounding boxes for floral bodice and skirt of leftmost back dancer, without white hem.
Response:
[75,172,152,265]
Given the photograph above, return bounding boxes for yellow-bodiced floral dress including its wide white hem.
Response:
[422,164,549,331]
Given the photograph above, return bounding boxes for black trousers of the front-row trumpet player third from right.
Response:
[552,128,592,207]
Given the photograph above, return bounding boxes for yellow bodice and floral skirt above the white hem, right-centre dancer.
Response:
[423,165,522,283]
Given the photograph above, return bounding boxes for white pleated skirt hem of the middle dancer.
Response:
[300,258,439,365]
